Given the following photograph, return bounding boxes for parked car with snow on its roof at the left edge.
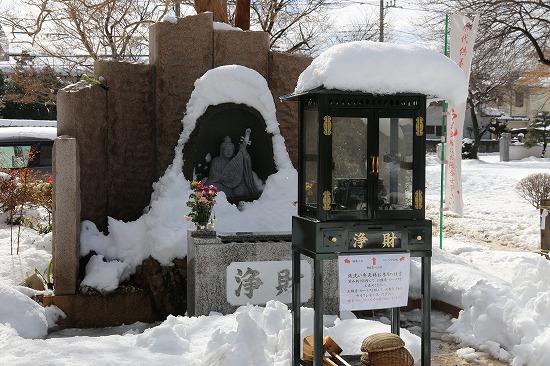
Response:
[0,127,57,174]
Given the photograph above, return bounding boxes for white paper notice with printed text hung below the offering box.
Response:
[338,253,411,310]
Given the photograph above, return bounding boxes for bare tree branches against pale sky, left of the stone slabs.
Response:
[0,0,174,70]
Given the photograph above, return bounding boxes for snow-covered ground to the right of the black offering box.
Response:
[422,154,550,366]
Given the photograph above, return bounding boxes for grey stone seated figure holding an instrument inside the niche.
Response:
[205,128,260,199]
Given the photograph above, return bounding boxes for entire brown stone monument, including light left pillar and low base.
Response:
[50,12,311,326]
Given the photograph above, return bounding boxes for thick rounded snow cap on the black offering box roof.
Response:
[294,41,468,105]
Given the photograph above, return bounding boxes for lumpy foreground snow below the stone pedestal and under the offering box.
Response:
[0,301,420,366]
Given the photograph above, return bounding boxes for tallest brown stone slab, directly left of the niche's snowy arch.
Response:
[149,13,214,180]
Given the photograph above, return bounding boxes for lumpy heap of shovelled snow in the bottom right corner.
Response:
[449,256,550,365]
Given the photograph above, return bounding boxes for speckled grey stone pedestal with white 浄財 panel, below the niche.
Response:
[187,230,339,316]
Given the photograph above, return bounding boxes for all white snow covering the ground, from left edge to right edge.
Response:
[0,155,550,366]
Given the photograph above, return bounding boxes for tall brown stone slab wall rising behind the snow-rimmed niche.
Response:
[54,13,311,298]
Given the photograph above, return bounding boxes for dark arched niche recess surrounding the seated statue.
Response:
[183,103,276,203]
